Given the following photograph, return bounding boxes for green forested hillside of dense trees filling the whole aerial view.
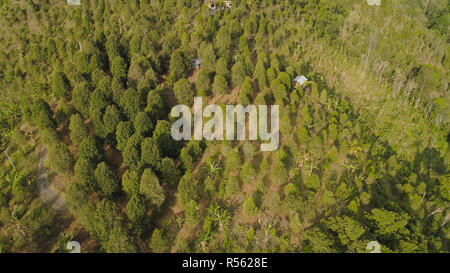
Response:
[0,0,450,253]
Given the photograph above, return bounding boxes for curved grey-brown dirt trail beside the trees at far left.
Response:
[37,146,67,212]
